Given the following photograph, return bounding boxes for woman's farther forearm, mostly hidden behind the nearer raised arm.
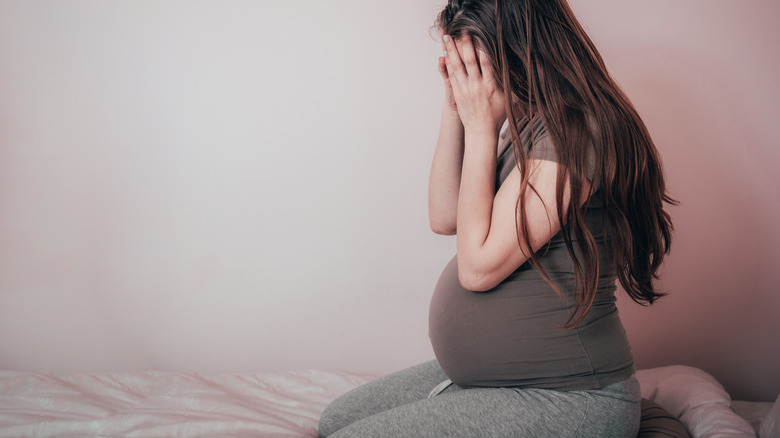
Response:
[428,51,463,235]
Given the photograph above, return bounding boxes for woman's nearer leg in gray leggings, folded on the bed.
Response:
[322,372,640,438]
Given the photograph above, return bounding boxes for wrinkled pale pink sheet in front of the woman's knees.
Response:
[0,370,373,438]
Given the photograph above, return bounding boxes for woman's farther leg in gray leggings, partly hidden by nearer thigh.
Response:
[318,360,447,437]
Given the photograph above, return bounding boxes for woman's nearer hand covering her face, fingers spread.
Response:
[439,35,506,134]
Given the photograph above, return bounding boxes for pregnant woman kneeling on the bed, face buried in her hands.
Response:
[319,0,674,437]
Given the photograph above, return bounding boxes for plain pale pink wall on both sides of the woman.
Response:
[0,0,780,400]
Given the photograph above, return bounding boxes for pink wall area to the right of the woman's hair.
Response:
[574,1,780,401]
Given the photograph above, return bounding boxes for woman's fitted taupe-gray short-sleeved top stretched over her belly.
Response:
[429,116,635,390]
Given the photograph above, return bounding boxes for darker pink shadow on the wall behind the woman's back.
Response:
[614,50,780,401]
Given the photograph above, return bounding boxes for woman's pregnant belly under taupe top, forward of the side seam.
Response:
[429,258,593,386]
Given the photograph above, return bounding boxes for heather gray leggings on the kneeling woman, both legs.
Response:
[319,361,640,438]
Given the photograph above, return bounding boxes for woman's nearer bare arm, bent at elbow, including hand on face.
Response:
[445,33,587,291]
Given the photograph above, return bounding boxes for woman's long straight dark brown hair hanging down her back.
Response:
[436,0,676,328]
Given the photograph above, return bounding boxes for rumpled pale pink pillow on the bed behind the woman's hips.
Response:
[636,365,755,438]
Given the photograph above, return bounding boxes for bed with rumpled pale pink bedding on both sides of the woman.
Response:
[0,366,780,438]
